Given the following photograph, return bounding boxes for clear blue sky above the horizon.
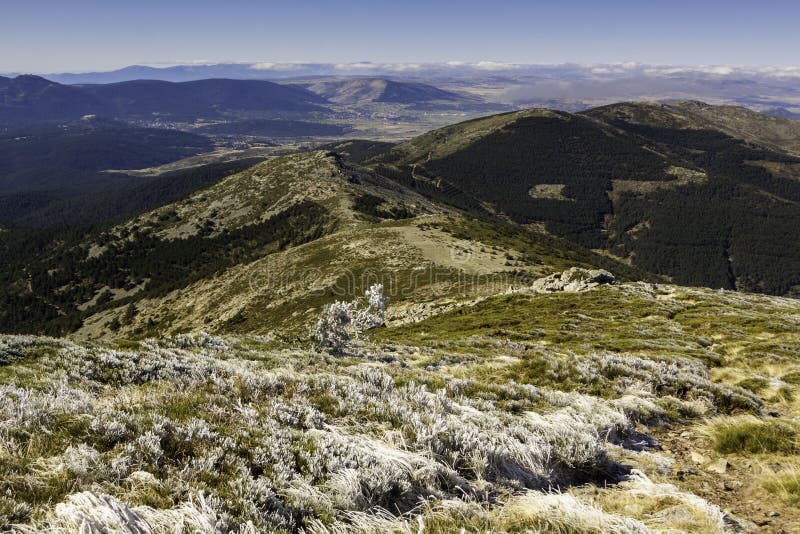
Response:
[0,0,800,73]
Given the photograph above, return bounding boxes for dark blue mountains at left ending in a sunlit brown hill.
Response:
[0,75,490,129]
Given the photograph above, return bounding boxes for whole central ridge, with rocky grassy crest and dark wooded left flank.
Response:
[0,151,647,336]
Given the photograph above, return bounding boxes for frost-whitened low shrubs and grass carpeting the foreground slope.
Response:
[0,332,756,532]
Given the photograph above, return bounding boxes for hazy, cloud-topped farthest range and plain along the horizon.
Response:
[3,61,800,118]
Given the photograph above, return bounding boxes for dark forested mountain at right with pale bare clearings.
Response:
[370,104,800,294]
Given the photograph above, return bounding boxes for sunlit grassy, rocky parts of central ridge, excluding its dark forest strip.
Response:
[78,152,640,335]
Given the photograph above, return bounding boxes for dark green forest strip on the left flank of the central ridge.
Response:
[0,202,331,335]
